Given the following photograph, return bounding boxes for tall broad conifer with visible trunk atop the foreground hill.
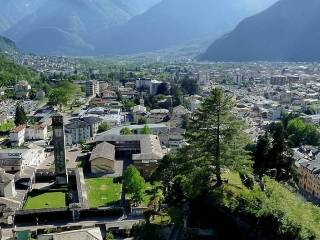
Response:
[186,88,248,186]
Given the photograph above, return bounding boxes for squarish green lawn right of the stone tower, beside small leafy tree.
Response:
[86,178,122,208]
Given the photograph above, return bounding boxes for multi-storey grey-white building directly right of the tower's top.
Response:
[65,117,103,146]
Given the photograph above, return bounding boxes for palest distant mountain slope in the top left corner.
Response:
[0,0,46,33]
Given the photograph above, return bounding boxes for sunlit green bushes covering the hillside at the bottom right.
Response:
[212,173,320,240]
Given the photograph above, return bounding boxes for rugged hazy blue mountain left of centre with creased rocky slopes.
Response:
[5,0,158,55]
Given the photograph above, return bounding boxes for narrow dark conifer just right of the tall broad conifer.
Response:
[253,133,270,178]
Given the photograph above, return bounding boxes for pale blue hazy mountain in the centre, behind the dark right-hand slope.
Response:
[96,0,275,54]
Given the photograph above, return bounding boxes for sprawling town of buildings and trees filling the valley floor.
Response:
[0,57,320,239]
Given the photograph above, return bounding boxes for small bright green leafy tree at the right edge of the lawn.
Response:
[123,165,145,205]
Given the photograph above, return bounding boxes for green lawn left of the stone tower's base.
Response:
[23,192,66,209]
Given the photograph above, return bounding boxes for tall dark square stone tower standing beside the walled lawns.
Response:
[52,113,68,185]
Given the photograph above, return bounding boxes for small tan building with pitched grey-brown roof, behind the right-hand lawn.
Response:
[90,142,115,174]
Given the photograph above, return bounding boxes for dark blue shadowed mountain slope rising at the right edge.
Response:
[201,0,320,61]
